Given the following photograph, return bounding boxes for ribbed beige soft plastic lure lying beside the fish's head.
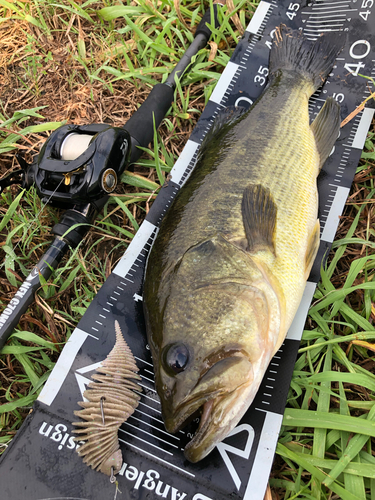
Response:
[73,321,142,480]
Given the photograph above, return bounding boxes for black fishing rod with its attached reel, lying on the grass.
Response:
[0,3,223,349]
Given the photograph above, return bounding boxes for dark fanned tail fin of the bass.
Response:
[270,25,344,92]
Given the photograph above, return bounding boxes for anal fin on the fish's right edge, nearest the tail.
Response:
[311,97,340,168]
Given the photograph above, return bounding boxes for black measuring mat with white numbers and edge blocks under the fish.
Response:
[0,0,375,500]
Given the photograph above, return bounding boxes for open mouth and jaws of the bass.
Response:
[165,355,256,463]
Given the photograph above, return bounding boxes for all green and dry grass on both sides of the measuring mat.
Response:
[0,0,375,500]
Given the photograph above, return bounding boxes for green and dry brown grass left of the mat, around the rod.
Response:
[0,0,255,454]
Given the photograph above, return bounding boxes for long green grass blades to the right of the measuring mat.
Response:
[271,133,375,500]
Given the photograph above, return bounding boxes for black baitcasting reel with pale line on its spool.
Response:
[22,124,130,209]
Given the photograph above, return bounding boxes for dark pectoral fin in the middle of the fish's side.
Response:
[241,184,277,255]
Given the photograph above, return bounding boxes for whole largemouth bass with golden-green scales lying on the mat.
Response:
[143,26,343,463]
